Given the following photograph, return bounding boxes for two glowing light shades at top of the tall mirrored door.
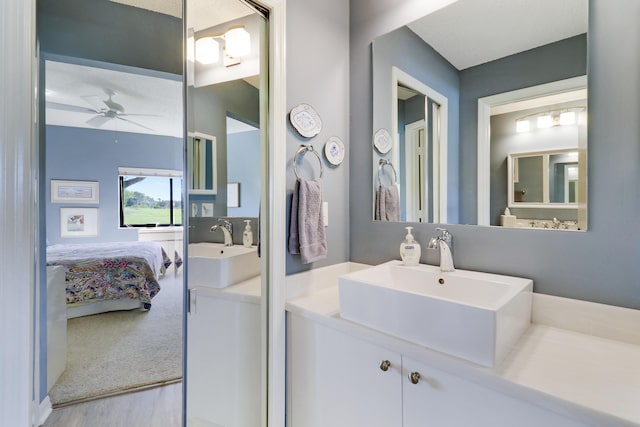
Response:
[195,26,251,67]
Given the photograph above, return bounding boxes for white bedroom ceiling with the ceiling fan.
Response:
[45,61,183,137]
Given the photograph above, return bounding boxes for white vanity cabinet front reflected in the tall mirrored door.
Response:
[186,288,262,427]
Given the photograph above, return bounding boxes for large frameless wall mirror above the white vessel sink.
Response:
[372,0,588,229]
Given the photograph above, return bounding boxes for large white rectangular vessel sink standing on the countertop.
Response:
[338,261,533,367]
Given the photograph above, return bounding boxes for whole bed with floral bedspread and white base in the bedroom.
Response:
[47,241,171,318]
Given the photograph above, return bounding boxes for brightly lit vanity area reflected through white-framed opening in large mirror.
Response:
[488,87,587,230]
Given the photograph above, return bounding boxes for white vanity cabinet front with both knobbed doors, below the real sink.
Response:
[287,313,584,427]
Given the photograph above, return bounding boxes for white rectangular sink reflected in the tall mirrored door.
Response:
[188,243,260,288]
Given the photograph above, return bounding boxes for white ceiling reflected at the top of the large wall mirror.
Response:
[408,0,588,70]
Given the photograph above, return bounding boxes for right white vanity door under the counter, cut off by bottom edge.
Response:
[402,357,583,427]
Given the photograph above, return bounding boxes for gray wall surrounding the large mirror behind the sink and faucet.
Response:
[349,0,640,309]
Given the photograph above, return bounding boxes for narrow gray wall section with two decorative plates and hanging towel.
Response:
[288,0,350,274]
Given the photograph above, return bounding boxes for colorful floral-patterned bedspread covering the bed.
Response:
[47,242,168,308]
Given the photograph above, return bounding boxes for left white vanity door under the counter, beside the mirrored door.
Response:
[287,314,402,427]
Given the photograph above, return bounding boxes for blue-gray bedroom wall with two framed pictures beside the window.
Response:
[45,126,182,243]
